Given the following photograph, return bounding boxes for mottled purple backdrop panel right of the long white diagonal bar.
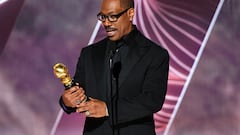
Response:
[169,0,240,135]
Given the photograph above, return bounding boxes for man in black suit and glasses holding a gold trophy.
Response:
[60,0,169,135]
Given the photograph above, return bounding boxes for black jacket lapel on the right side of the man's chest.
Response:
[119,41,149,88]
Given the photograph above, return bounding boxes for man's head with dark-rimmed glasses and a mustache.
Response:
[99,0,134,41]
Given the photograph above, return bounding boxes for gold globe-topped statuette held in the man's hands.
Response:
[53,63,75,89]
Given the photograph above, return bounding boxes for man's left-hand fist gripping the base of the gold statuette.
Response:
[62,86,86,107]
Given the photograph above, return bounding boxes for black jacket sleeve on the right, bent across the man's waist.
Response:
[107,50,169,125]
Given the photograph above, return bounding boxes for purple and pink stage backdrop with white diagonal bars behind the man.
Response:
[0,0,240,135]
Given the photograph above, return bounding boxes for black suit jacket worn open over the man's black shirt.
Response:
[62,29,169,135]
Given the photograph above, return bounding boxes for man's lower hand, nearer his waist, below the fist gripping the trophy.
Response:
[77,97,107,118]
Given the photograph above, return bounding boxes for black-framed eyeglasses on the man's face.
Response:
[97,8,130,22]
